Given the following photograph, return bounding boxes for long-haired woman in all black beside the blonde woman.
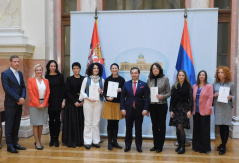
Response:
[45,60,65,147]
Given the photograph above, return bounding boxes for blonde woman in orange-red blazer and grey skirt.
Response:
[28,64,50,150]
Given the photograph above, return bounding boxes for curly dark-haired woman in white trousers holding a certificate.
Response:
[80,62,104,149]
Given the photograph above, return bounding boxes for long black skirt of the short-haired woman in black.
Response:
[62,103,84,147]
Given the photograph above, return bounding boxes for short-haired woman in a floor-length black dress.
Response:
[62,62,84,148]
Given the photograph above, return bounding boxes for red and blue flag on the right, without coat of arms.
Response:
[176,19,196,85]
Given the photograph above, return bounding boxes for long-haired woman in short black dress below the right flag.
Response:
[169,70,193,154]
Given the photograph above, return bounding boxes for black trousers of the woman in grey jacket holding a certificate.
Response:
[149,104,168,149]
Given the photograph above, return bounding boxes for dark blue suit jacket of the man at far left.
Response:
[1,68,26,106]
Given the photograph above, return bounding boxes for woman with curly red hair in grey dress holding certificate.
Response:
[213,66,235,155]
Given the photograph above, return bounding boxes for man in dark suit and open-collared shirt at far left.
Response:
[1,55,26,153]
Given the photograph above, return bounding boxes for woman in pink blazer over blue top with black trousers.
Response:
[192,70,213,153]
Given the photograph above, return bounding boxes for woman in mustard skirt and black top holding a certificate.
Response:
[102,63,125,150]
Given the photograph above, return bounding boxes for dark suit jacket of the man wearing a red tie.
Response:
[120,80,149,116]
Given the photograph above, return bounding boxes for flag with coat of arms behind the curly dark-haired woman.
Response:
[86,19,106,79]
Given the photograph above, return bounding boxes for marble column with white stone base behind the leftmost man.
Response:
[0,0,35,137]
